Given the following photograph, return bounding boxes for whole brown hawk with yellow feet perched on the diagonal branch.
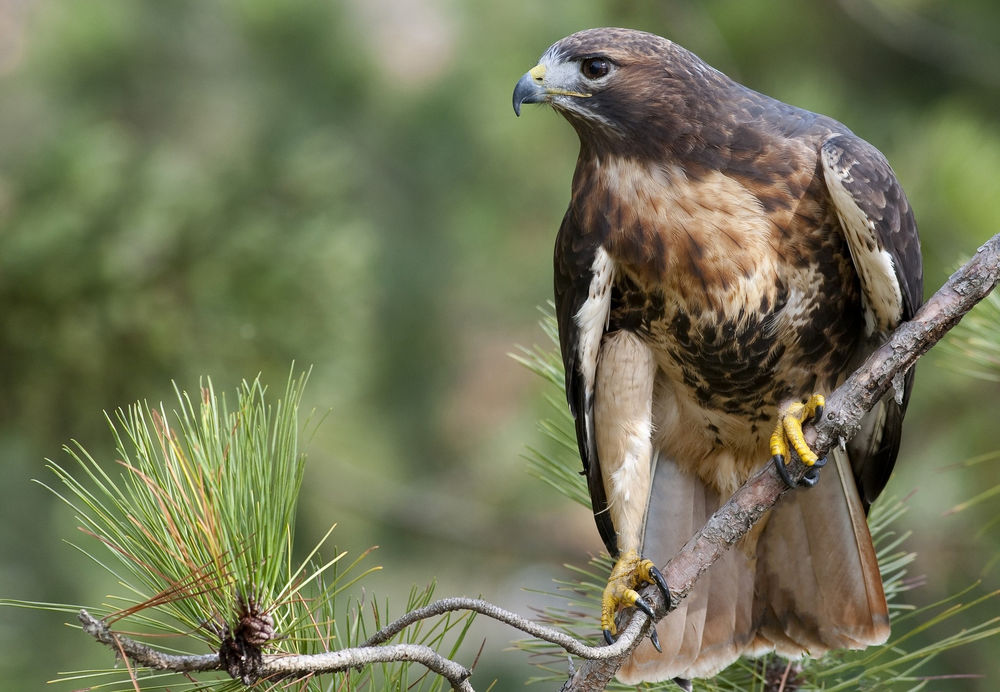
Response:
[514,28,923,683]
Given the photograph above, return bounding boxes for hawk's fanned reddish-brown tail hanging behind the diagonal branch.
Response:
[618,450,889,684]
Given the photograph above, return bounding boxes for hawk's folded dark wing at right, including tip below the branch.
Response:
[822,134,923,511]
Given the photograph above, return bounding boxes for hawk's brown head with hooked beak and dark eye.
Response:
[514,28,733,151]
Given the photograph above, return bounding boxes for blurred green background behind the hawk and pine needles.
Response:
[0,0,1000,690]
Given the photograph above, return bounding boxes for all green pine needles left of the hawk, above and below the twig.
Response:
[5,375,472,692]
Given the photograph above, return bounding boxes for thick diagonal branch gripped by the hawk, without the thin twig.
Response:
[563,234,1000,692]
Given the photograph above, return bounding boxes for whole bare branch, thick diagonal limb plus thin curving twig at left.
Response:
[79,234,1000,692]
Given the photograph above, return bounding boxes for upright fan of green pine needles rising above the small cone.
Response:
[47,378,324,644]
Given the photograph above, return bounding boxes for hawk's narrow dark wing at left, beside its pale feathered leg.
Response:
[555,206,618,556]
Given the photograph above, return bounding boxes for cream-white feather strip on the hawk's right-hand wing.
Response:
[823,150,903,336]
